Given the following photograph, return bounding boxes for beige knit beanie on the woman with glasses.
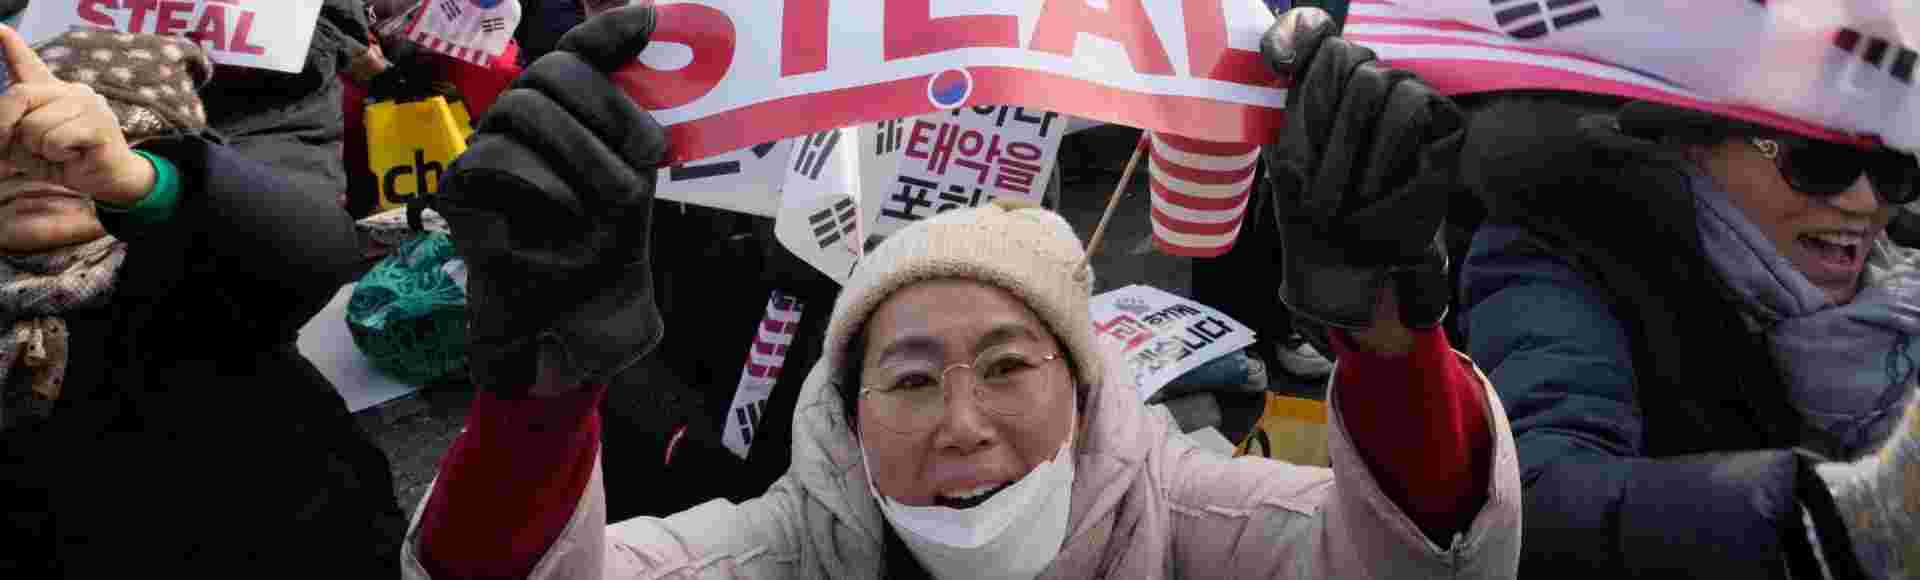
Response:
[828,204,1102,386]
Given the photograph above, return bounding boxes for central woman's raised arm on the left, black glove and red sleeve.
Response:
[415,6,666,578]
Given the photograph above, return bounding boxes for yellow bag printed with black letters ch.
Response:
[367,96,470,211]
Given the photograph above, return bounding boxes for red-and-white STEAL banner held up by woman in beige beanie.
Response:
[618,0,1284,161]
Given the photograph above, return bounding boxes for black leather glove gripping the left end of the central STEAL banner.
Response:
[430,4,666,396]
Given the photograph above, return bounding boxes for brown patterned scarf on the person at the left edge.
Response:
[0,236,127,430]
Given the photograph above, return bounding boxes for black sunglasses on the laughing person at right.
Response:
[1751,136,1920,205]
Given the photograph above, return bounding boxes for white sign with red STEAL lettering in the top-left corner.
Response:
[19,0,323,73]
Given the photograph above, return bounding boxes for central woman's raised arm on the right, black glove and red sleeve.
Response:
[1261,8,1500,545]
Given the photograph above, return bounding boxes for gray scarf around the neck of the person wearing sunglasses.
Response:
[1693,175,1920,459]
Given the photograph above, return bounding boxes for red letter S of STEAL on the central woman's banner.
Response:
[614,4,735,109]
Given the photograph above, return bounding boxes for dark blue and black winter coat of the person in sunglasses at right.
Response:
[1461,92,1824,578]
